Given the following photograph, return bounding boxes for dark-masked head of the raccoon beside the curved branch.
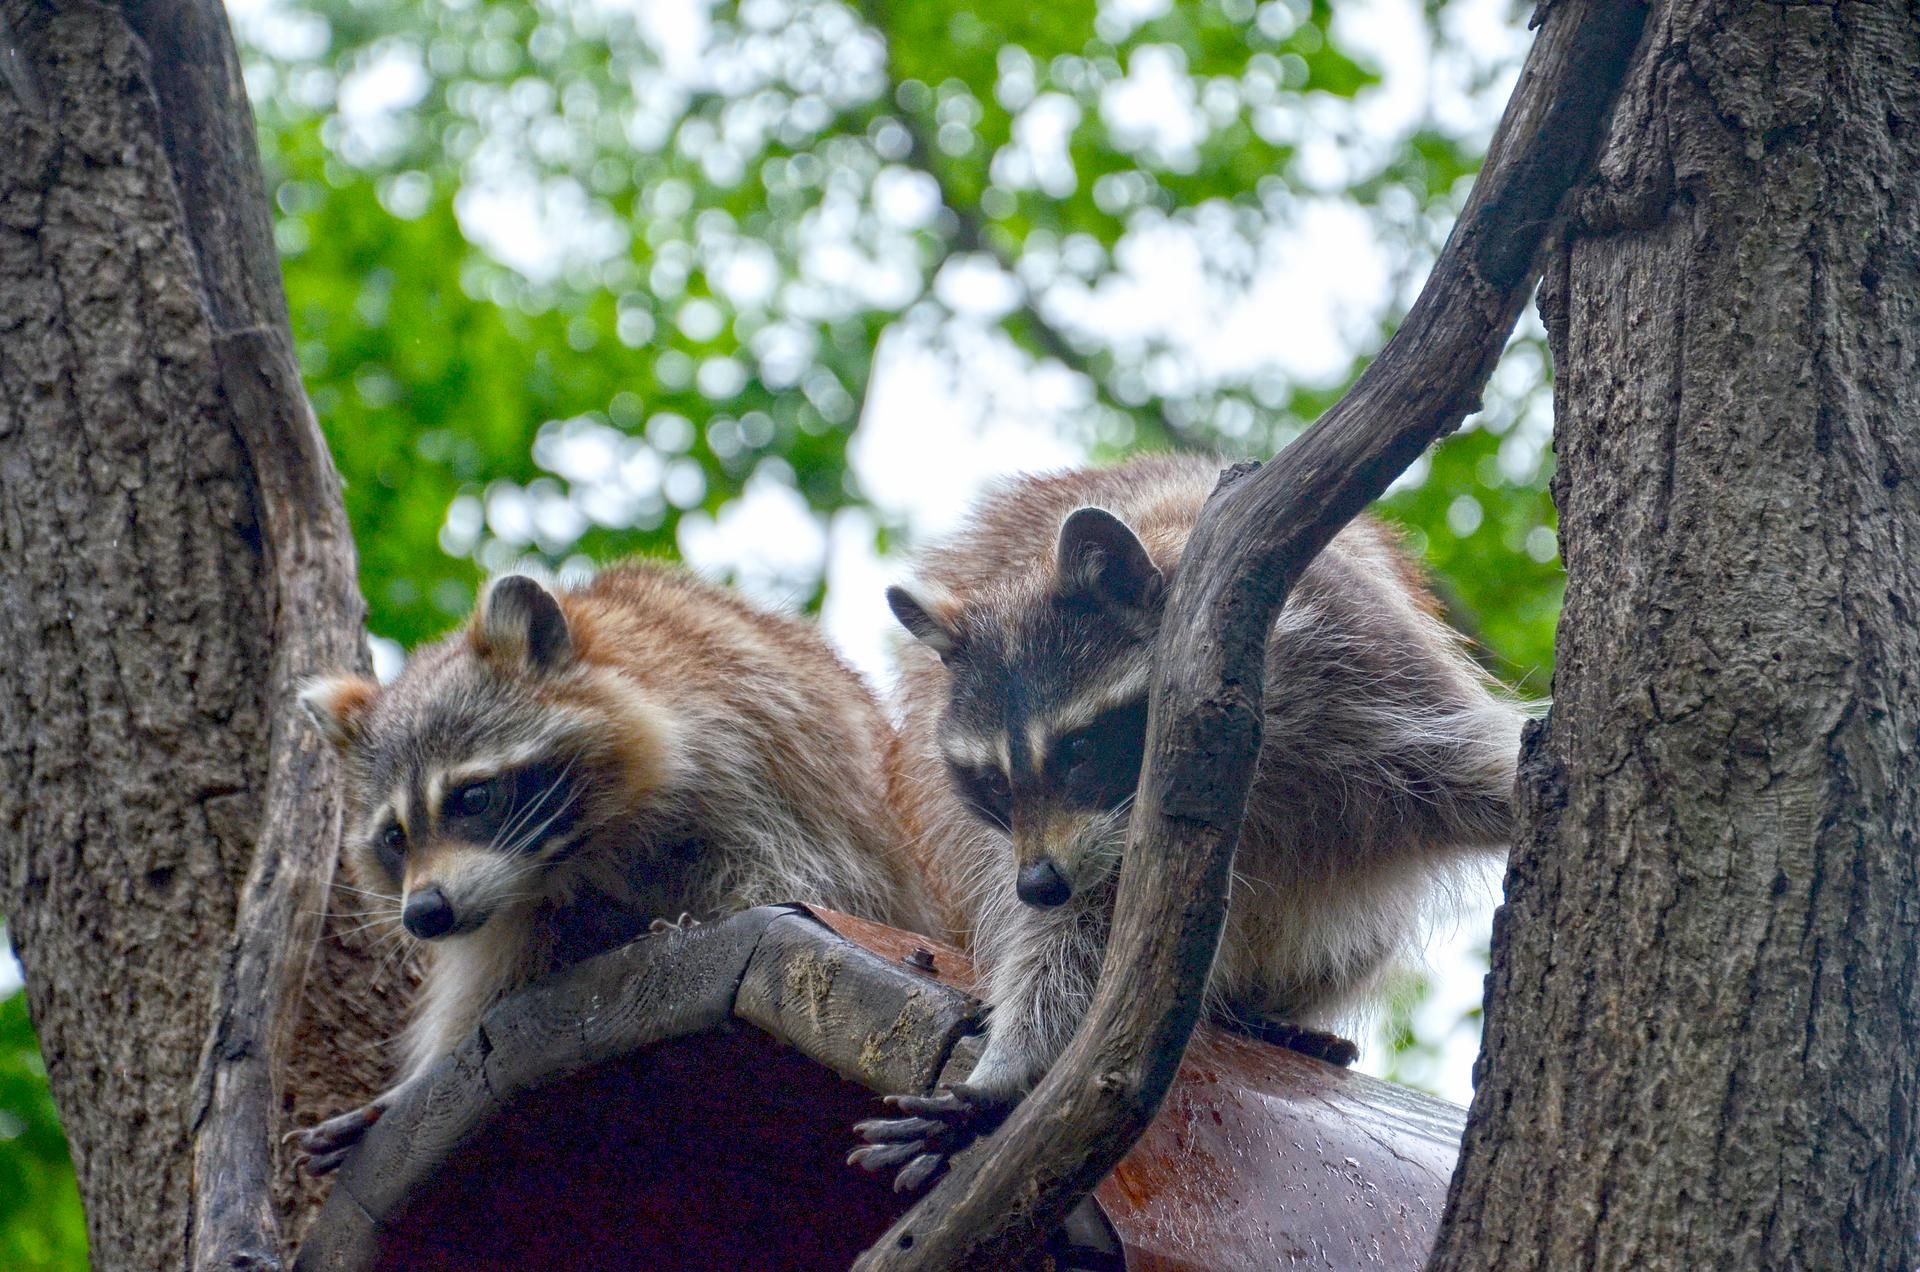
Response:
[887,507,1165,907]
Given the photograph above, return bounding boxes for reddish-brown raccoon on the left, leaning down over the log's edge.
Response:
[286,563,925,1174]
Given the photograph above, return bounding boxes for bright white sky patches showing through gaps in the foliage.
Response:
[0,0,1526,1101]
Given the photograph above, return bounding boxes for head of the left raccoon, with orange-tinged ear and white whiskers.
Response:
[301,576,666,940]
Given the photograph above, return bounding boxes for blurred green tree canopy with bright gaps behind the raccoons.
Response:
[0,0,1561,1268]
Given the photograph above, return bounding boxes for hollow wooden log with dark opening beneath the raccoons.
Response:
[298,907,1461,1272]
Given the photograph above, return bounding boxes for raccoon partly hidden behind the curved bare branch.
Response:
[854,457,1524,1187]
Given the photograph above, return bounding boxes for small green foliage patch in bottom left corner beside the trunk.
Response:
[0,979,86,1272]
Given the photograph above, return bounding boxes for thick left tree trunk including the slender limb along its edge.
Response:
[0,0,408,1268]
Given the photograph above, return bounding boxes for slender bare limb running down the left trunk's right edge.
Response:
[121,0,382,1270]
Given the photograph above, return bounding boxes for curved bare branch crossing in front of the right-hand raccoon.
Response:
[856,0,1645,1272]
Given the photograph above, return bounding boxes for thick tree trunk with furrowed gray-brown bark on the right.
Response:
[1432,0,1920,1270]
